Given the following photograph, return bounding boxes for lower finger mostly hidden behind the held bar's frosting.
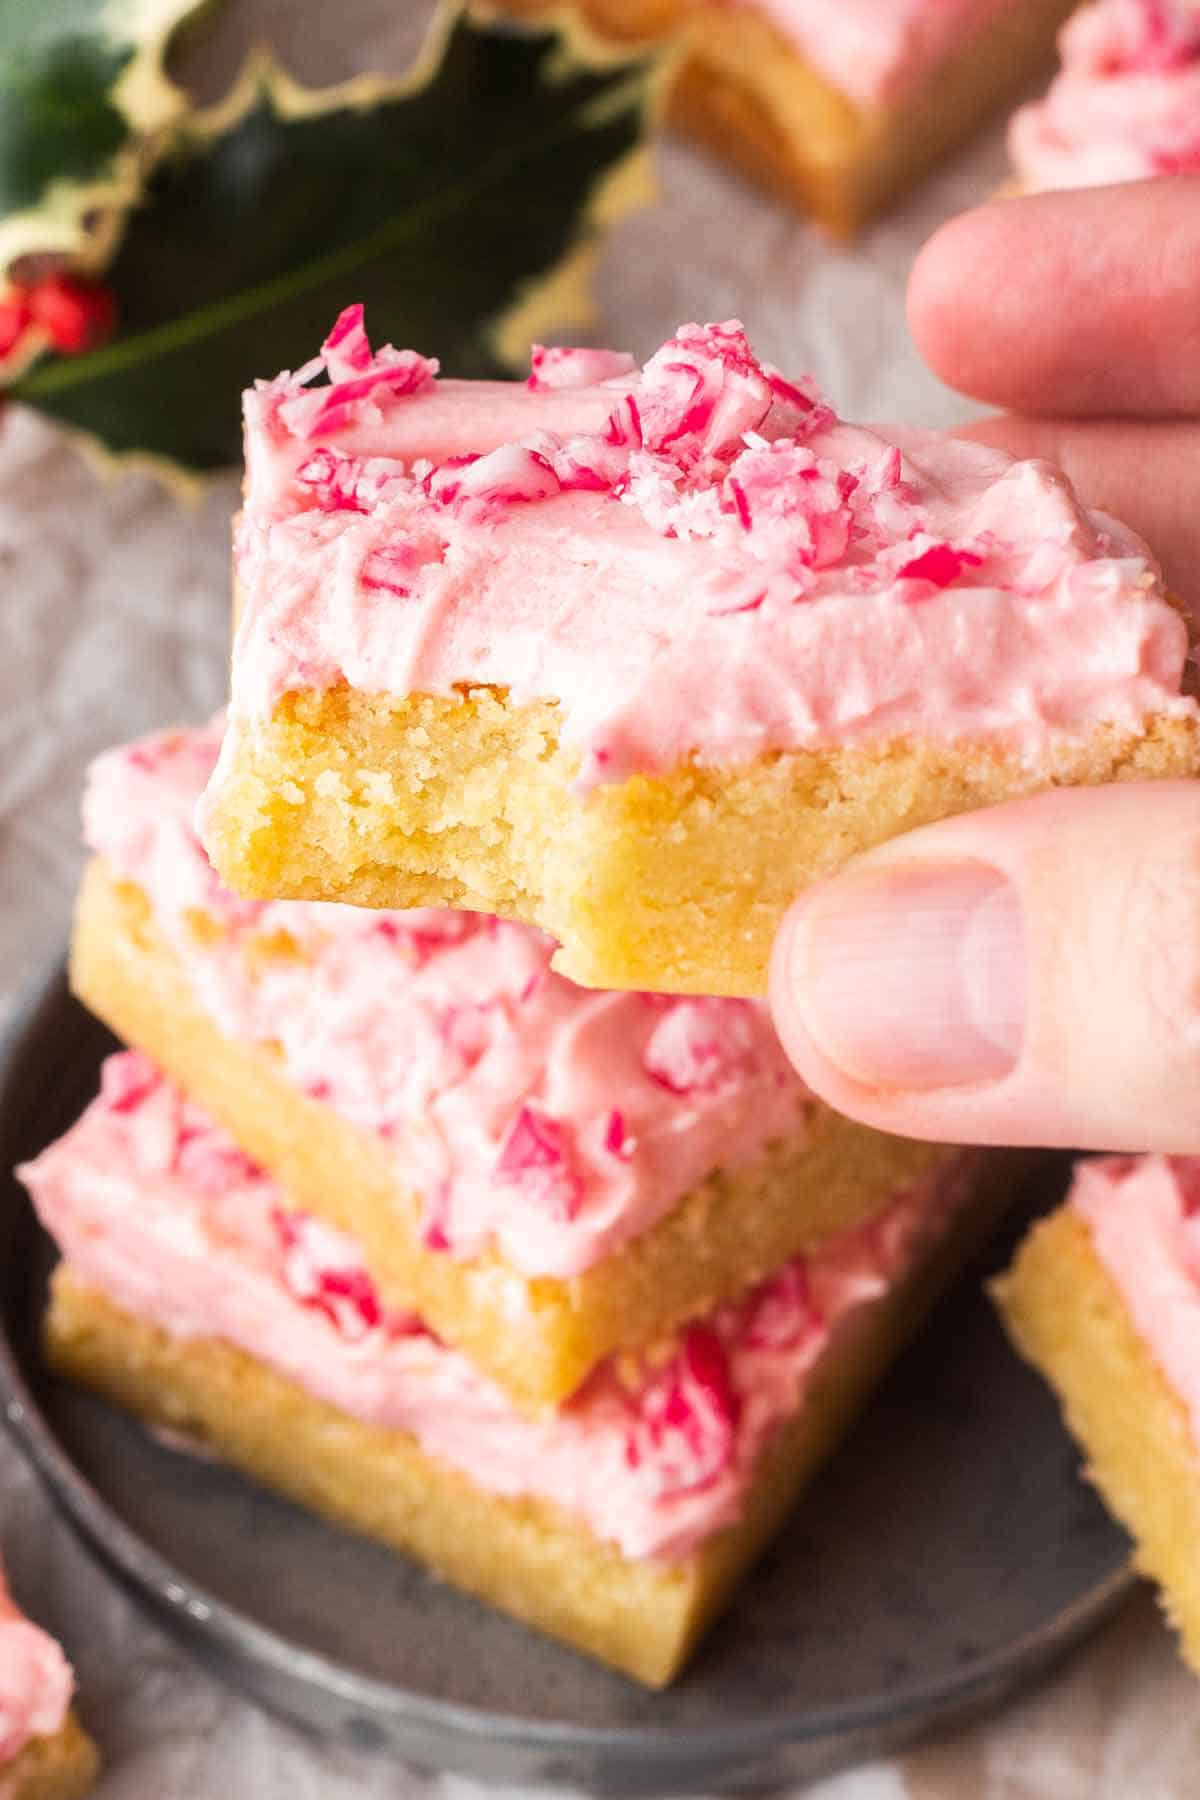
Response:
[955,416,1200,619]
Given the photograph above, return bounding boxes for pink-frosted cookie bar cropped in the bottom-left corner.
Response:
[0,1570,97,1800]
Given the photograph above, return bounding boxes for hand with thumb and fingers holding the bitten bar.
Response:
[772,176,1200,1152]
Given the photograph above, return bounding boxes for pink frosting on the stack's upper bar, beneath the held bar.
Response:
[85,720,813,1276]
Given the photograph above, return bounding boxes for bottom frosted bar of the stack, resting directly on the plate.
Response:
[22,1053,970,1683]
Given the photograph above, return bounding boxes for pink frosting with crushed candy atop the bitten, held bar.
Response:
[201,308,1195,824]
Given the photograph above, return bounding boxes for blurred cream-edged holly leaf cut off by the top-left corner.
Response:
[0,0,207,274]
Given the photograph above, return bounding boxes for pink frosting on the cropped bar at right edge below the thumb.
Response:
[1070,1156,1200,1449]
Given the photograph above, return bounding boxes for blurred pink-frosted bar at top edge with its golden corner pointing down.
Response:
[506,0,1069,236]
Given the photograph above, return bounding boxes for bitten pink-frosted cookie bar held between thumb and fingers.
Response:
[201,310,1196,994]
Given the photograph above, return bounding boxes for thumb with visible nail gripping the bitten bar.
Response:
[772,781,1200,1152]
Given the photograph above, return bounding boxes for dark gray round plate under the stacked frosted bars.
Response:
[0,972,1130,1795]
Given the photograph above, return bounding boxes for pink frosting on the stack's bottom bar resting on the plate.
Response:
[20,1051,968,1559]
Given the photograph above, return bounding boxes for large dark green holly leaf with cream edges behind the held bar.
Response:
[13,9,657,472]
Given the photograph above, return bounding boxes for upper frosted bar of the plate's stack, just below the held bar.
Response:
[72,729,950,1406]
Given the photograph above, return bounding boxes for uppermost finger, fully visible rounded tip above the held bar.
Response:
[909,175,1200,418]
